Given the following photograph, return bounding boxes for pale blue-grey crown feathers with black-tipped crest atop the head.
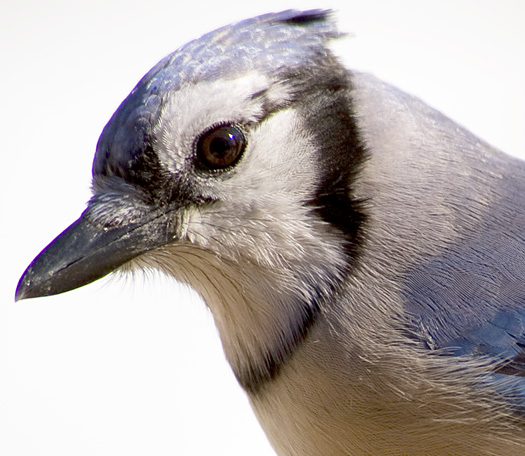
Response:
[140,10,341,94]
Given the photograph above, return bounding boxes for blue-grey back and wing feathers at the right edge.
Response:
[403,168,525,406]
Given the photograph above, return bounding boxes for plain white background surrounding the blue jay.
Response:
[0,0,525,456]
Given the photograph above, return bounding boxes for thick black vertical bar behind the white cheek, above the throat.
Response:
[303,69,367,268]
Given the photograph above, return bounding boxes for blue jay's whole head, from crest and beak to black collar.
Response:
[16,10,365,390]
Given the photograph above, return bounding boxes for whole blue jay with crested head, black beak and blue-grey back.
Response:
[15,9,525,456]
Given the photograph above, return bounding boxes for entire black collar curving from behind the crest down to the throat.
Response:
[237,64,367,394]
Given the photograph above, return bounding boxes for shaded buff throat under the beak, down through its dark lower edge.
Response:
[146,239,348,393]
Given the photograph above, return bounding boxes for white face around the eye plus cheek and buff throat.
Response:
[135,72,346,388]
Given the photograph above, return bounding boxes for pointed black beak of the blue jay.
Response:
[15,211,174,301]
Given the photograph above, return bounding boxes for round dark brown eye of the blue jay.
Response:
[195,124,246,170]
